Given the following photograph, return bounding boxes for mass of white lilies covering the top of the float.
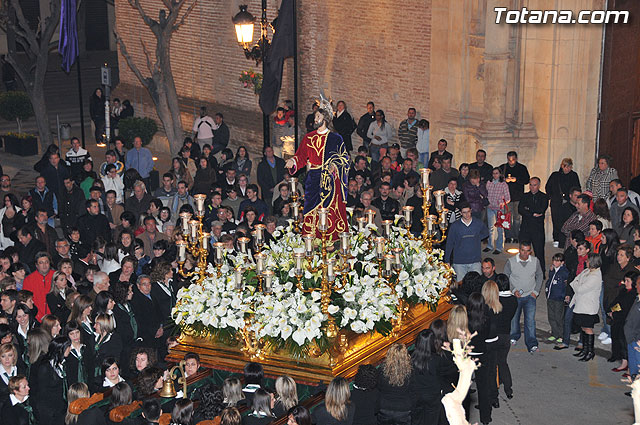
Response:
[172,220,451,355]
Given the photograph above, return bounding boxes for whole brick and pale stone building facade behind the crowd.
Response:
[115,0,604,184]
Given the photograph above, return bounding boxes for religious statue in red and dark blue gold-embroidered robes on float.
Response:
[285,97,349,241]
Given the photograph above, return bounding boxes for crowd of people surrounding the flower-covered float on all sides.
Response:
[0,97,640,425]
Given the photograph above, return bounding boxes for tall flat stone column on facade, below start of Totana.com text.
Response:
[482,0,511,133]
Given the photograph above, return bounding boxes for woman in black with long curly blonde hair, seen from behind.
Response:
[378,343,413,424]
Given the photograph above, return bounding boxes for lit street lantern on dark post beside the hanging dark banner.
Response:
[231,0,272,147]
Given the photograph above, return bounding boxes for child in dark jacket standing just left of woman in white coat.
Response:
[546,252,569,341]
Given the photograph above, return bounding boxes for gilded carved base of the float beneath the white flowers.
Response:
[168,297,452,384]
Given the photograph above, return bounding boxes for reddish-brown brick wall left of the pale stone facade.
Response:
[115,0,431,151]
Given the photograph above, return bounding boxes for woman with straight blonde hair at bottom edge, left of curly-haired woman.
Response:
[311,376,356,425]
